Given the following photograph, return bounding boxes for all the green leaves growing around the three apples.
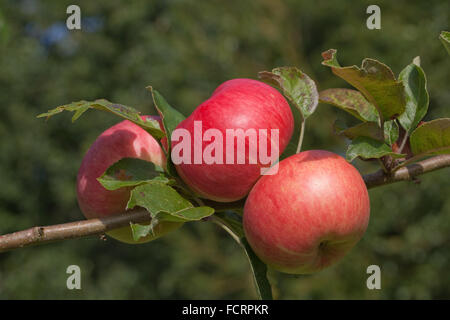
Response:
[38,32,450,299]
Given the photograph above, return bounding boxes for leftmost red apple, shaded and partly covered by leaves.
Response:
[77,117,181,243]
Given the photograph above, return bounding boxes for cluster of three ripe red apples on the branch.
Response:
[77,79,370,274]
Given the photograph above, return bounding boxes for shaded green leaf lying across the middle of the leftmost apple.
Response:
[97,158,170,190]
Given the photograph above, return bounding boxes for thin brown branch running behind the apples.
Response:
[0,155,450,253]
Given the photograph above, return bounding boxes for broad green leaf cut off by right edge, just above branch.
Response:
[409,118,450,155]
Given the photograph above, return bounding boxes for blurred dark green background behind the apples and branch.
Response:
[0,0,450,299]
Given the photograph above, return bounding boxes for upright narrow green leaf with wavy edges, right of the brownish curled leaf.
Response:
[398,63,429,135]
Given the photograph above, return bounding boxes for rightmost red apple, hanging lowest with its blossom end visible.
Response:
[243,150,370,274]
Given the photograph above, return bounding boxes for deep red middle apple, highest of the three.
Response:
[172,79,294,202]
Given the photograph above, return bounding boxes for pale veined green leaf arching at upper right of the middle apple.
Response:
[258,67,319,119]
